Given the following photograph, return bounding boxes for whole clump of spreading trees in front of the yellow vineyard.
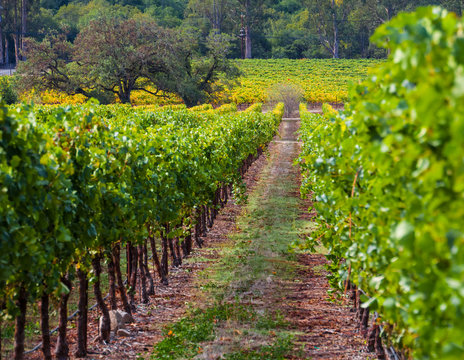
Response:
[18,16,236,106]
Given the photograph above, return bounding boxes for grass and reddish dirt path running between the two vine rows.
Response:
[21,119,374,360]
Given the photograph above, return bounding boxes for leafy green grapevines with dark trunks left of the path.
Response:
[0,105,283,359]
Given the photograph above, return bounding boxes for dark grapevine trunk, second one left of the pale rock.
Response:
[75,269,89,358]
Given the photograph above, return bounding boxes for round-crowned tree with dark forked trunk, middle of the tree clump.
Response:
[74,17,174,103]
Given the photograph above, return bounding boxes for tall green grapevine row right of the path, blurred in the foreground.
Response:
[300,8,464,359]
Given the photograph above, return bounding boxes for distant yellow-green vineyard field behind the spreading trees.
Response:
[18,59,382,105]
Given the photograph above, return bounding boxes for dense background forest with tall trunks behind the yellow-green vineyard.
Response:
[0,0,464,66]
